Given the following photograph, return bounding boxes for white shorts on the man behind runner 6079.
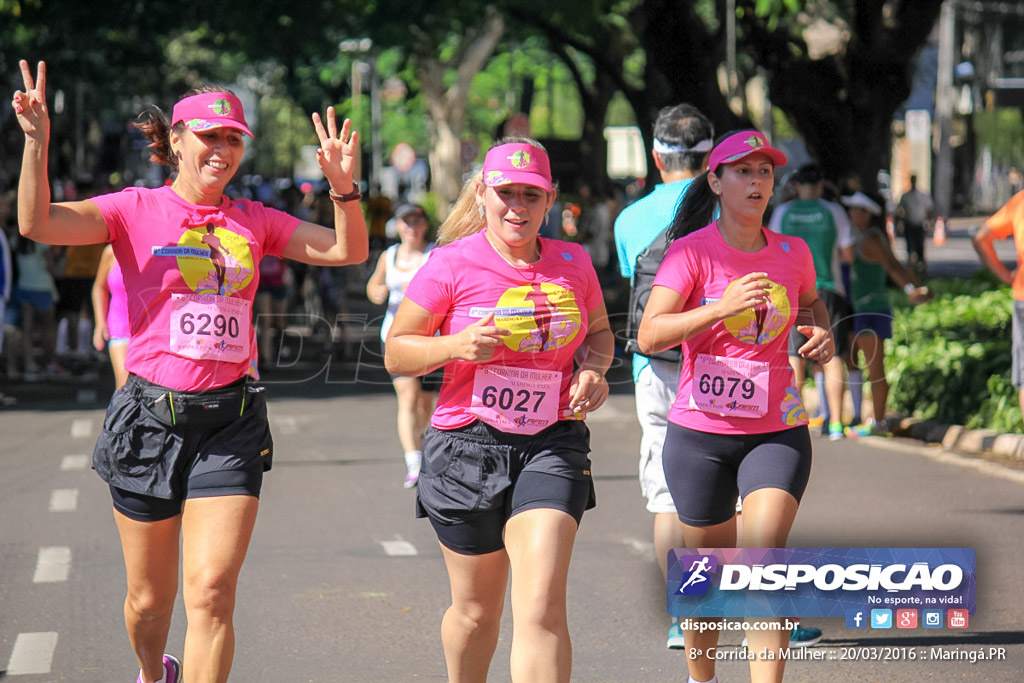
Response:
[634,360,680,514]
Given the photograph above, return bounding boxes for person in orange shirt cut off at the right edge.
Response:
[974,191,1024,412]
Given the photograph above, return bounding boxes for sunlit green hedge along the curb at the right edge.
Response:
[886,271,1024,433]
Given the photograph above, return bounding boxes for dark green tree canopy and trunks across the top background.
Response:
[0,0,941,201]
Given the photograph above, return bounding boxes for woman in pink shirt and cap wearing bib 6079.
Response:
[637,130,835,682]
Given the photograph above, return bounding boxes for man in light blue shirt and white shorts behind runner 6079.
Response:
[614,104,715,648]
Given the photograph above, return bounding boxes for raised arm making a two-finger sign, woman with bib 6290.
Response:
[11,59,110,245]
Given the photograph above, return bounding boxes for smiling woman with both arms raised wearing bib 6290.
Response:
[11,60,368,683]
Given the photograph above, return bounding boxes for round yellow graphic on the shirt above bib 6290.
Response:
[177,225,255,296]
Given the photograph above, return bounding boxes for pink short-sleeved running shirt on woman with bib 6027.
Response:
[406,230,603,429]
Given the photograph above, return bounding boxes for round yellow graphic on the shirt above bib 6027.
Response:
[495,283,583,353]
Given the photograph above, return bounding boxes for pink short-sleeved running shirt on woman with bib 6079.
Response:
[654,221,814,434]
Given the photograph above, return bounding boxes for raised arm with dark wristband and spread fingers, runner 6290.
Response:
[283,106,370,265]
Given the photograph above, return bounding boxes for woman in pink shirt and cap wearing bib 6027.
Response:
[385,138,614,682]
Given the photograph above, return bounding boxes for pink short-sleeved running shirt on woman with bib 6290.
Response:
[90,185,300,391]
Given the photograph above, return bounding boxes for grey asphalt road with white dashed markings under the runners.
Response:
[0,377,1024,683]
